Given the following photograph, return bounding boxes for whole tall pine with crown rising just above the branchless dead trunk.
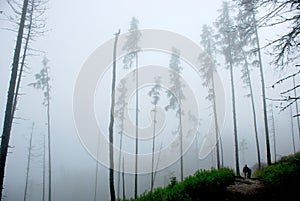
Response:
[123,17,141,199]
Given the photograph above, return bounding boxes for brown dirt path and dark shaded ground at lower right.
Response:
[225,177,300,201]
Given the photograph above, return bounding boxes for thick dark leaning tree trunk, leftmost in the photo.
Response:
[0,0,28,199]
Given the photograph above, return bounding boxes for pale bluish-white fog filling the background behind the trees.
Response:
[0,0,300,201]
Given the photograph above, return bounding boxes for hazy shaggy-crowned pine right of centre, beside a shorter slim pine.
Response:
[165,48,185,181]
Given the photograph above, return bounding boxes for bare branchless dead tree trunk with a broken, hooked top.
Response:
[109,30,120,201]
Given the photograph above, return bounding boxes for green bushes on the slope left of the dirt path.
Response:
[123,168,235,201]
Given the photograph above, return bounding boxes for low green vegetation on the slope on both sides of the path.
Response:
[120,153,300,201]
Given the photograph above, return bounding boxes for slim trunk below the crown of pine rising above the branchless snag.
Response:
[134,52,139,199]
